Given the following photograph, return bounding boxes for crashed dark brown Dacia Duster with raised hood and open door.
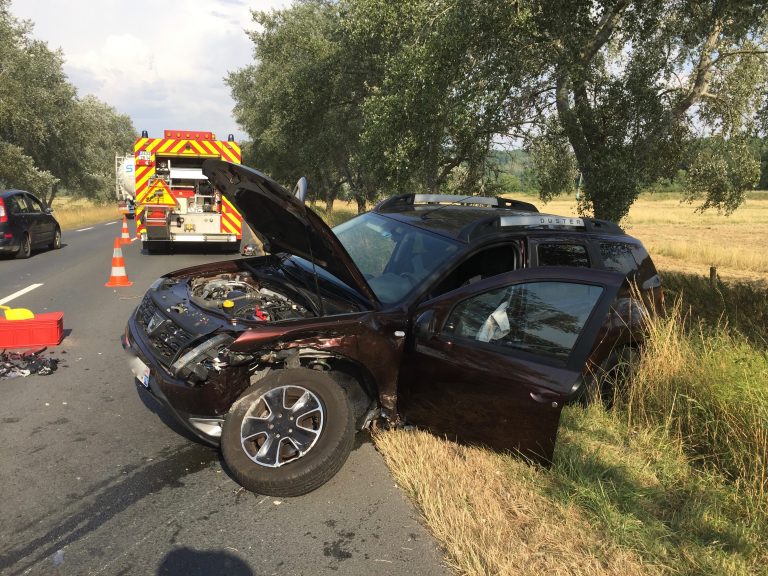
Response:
[123,160,660,495]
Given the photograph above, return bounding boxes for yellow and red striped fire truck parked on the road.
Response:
[133,130,243,252]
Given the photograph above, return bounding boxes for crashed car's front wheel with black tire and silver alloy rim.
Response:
[221,368,355,496]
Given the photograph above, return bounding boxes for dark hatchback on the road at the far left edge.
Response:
[0,190,61,258]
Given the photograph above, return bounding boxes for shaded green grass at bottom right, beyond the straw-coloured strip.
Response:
[541,407,767,576]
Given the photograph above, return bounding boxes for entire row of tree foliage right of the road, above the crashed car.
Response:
[228,0,768,220]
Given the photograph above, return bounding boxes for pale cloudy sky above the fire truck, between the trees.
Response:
[11,0,290,140]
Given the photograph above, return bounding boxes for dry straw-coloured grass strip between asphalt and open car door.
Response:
[376,430,659,576]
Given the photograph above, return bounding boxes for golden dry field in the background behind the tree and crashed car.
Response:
[539,192,768,285]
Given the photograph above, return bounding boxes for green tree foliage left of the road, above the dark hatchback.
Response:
[0,0,136,204]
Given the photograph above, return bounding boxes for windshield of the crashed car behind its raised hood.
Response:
[333,212,460,304]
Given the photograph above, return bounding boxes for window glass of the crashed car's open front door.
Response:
[444,281,603,360]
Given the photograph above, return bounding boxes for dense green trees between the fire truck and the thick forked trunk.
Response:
[227,0,527,210]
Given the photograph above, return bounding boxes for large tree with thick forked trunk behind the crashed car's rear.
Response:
[534,0,768,220]
